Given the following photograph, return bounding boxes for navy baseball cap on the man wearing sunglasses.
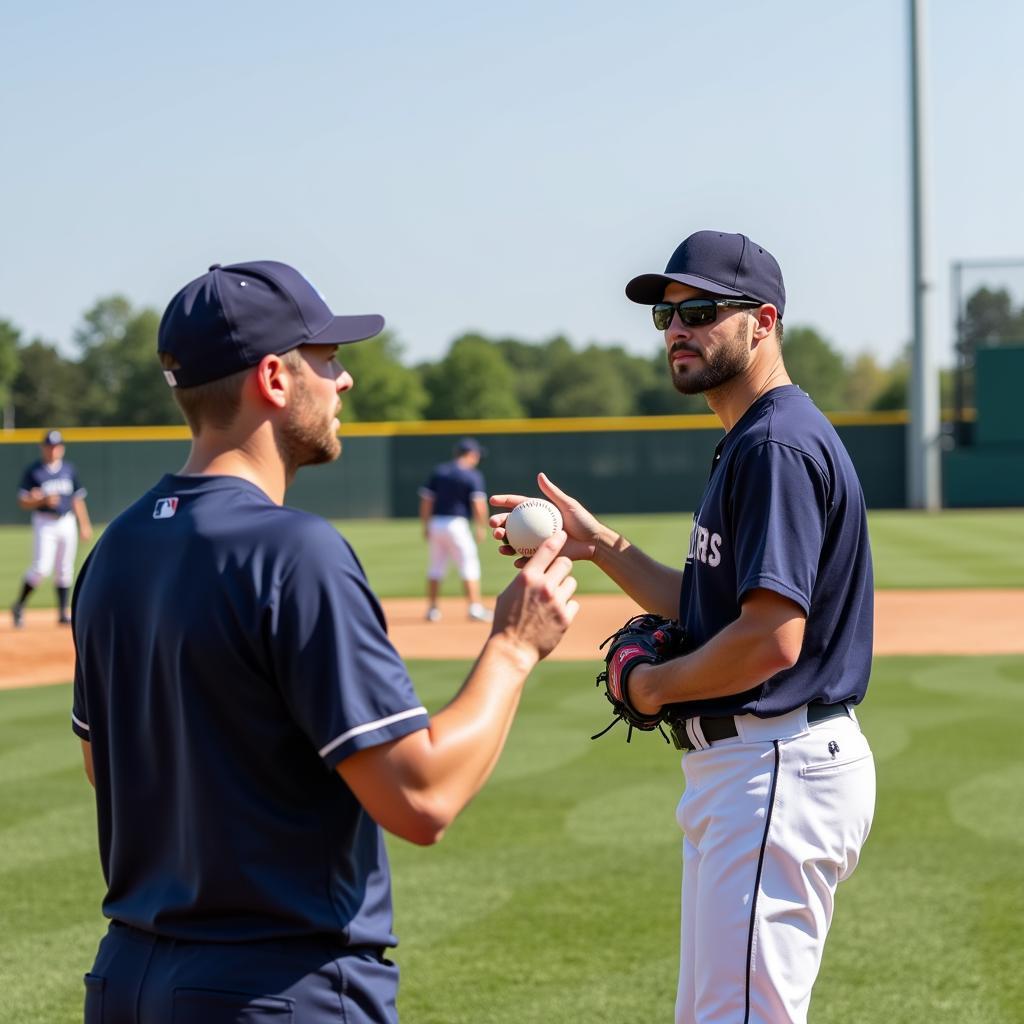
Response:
[626,231,785,319]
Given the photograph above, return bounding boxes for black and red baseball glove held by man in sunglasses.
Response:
[590,613,686,742]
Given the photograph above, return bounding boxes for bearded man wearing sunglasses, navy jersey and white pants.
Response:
[490,231,874,1024]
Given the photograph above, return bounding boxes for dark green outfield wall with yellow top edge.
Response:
[0,413,921,523]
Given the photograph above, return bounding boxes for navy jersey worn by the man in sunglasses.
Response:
[680,384,873,717]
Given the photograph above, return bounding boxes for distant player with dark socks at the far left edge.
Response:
[11,430,92,629]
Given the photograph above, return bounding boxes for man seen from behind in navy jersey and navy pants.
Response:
[73,261,578,1024]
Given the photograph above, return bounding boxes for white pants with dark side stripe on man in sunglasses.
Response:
[676,718,874,1024]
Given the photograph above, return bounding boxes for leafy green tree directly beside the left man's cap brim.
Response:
[338,331,428,423]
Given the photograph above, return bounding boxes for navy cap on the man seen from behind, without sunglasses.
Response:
[157,260,384,387]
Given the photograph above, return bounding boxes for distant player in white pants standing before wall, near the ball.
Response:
[419,437,490,623]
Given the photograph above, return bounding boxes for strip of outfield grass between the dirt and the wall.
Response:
[0,509,1024,607]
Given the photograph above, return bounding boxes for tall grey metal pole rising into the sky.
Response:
[906,0,942,509]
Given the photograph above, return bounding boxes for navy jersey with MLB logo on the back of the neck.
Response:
[73,476,428,946]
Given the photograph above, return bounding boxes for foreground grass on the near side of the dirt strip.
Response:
[0,657,1024,1024]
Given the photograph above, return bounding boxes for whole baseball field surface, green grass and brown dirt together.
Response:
[0,510,1024,1024]
